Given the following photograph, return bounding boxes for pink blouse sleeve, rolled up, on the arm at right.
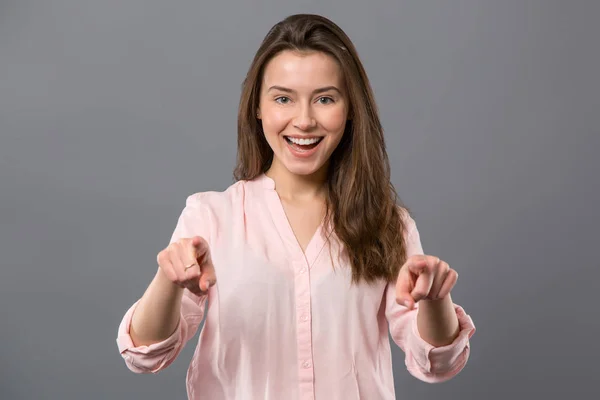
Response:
[386,212,475,383]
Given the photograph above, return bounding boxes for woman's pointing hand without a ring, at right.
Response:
[396,255,458,309]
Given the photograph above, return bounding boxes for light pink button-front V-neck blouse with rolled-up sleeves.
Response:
[117,174,475,400]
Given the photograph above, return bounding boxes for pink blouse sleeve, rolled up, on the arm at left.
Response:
[117,194,210,373]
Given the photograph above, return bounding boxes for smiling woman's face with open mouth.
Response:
[257,50,348,175]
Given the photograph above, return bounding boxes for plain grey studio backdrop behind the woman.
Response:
[0,0,600,399]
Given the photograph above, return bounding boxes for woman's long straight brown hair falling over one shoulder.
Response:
[234,14,408,283]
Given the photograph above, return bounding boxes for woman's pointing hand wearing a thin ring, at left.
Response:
[156,236,217,295]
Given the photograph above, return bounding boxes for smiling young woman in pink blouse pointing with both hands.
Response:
[117,15,475,400]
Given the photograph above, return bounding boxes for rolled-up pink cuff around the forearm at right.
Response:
[407,304,475,381]
